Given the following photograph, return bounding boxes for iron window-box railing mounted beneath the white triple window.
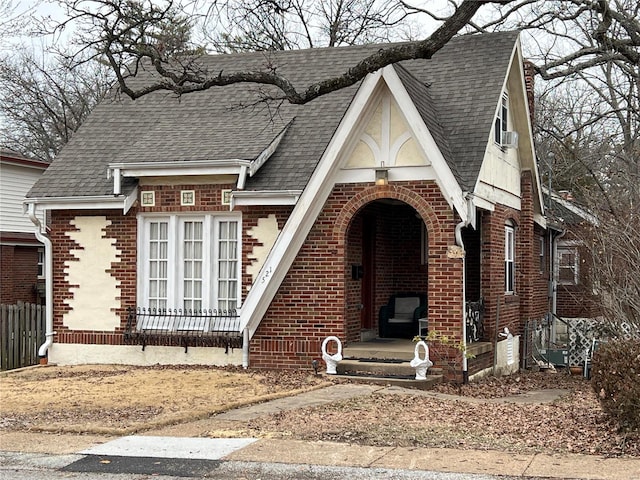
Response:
[124,307,242,353]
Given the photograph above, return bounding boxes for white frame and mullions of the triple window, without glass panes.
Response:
[137,213,242,316]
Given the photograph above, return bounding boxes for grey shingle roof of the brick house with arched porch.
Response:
[28,32,517,197]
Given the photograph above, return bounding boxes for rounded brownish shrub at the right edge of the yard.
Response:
[591,340,640,430]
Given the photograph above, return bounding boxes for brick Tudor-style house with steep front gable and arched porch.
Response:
[28,32,548,375]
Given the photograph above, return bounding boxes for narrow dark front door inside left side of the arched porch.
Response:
[360,215,376,330]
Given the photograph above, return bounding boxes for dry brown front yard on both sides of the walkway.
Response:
[0,366,640,456]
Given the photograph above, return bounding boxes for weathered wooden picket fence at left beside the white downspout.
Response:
[0,303,45,370]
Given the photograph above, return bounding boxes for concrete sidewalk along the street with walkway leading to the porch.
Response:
[0,384,640,480]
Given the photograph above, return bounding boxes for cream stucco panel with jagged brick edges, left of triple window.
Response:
[62,216,120,331]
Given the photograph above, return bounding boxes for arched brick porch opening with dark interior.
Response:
[332,184,450,342]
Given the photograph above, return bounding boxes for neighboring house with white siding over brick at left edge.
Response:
[0,149,49,304]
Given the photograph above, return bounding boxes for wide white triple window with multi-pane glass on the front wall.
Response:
[138,214,241,311]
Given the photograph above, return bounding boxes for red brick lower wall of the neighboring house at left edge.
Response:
[0,245,38,304]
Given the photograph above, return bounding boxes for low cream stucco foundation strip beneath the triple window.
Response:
[49,343,242,366]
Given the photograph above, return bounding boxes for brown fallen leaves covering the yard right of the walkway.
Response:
[247,374,640,456]
